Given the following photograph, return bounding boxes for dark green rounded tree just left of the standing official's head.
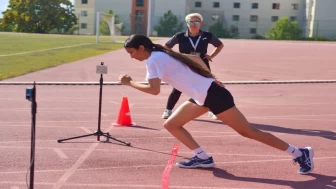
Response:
[154,10,183,37]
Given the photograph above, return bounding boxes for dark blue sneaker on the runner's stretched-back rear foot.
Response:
[293,147,314,175]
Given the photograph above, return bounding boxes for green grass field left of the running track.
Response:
[0,33,159,80]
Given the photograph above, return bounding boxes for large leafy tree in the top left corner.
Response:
[1,0,77,33]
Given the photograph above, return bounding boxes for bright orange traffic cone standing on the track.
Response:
[112,97,135,126]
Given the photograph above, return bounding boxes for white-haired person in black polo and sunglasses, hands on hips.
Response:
[162,13,224,119]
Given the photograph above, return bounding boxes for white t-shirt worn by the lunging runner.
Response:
[146,51,215,105]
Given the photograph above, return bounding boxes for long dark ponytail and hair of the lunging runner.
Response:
[124,34,215,78]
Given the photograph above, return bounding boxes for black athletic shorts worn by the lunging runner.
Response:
[189,82,235,115]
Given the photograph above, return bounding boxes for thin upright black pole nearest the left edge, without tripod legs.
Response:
[29,82,37,189]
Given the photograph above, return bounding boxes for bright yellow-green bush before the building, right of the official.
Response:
[267,17,302,40]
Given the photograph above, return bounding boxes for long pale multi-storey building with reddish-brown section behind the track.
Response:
[75,0,336,38]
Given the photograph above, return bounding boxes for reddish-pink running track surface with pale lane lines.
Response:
[0,40,336,189]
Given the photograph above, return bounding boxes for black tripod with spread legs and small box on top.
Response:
[57,62,131,146]
